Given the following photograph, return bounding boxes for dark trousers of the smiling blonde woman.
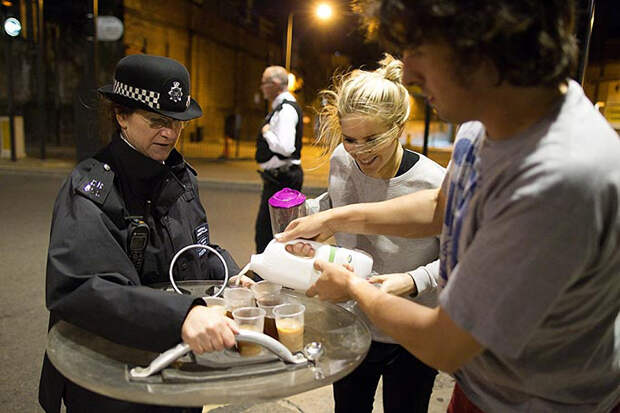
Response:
[334,341,437,413]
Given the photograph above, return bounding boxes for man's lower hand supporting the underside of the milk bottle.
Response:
[306,260,367,303]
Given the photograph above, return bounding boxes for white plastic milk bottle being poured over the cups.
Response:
[244,240,373,291]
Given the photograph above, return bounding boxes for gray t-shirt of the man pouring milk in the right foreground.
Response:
[440,81,620,413]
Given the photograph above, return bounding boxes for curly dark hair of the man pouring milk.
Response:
[354,0,577,86]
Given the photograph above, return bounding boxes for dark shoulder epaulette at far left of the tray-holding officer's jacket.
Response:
[75,158,114,205]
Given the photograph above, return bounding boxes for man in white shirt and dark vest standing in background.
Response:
[255,66,304,253]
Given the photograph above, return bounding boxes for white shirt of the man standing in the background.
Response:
[259,92,301,169]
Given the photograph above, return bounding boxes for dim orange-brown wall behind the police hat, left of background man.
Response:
[123,0,282,157]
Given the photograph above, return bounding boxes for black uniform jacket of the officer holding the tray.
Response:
[39,138,239,412]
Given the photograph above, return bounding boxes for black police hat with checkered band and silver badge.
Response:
[99,55,202,120]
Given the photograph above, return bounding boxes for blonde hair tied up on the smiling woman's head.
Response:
[317,53,409,156]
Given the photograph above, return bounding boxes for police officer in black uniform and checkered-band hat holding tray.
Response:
[39,55,239,413]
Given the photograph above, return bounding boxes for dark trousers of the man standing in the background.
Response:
[254,165,304,254]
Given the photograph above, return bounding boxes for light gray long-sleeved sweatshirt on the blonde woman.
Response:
[307,145,445,343]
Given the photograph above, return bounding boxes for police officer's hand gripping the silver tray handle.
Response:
[181,305,239,354]
